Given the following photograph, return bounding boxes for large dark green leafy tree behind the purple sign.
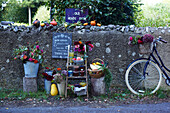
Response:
[45,0,140,25]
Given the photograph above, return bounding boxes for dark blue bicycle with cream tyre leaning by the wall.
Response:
[125,36,170,95]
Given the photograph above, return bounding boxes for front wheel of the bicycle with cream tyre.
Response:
[125,59,162,95]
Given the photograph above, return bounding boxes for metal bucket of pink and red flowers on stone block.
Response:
[13,42,44,77]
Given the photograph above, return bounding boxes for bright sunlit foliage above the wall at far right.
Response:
[135,3,170,27]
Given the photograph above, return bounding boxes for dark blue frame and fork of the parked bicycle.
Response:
[143,45,170,80]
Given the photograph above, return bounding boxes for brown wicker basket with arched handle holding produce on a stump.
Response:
[88,58,104,78]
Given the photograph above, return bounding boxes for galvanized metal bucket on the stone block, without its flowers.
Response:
[24,62,39,78]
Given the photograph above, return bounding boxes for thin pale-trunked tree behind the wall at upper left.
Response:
[21,0,47,25]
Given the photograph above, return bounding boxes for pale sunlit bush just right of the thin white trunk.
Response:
[33,6,50,22]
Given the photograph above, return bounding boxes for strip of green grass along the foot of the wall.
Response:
[0,87,170,102]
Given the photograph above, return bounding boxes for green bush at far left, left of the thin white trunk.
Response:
[2,0,27,23]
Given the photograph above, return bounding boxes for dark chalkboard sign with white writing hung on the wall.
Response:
[52,33,72,58]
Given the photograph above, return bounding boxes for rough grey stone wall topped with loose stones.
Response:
[0,25,170,89]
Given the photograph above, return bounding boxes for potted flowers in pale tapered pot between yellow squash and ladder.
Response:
[53,68,67,96]
